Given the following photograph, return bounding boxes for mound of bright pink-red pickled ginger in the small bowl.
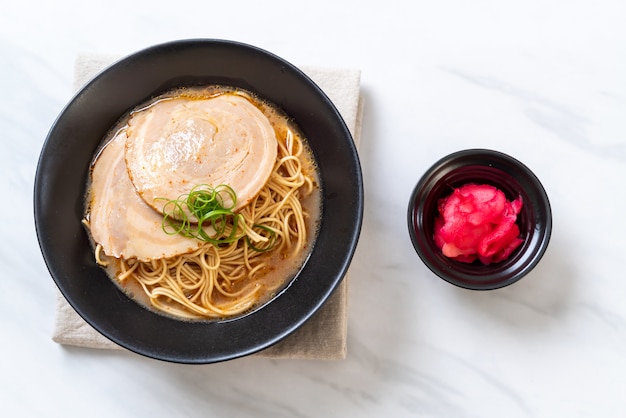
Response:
[434,184,523,264]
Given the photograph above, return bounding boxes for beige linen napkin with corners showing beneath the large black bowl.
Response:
[52,54,362,360]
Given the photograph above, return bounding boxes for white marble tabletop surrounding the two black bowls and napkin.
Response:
[0,0,626,418]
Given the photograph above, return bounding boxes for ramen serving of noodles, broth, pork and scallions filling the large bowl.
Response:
[83,86,320,319]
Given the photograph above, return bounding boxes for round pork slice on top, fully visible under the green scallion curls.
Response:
[126,93,277,217]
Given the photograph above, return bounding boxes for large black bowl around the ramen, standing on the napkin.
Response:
[34,39,363,364]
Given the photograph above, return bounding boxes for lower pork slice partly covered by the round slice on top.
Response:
[89,131,203,261]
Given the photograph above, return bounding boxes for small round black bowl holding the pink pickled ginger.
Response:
[408,149,552,290]
